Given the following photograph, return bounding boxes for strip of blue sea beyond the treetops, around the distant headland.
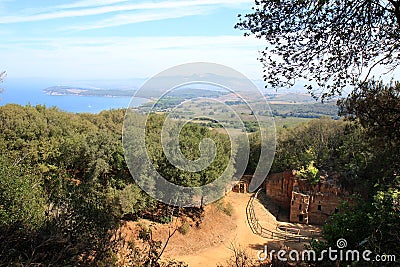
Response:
[0,78,148,113]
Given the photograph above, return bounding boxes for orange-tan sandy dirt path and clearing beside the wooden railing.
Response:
[120,192,318,267]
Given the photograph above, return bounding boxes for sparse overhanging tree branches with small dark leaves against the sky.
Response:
[235,0,400,98]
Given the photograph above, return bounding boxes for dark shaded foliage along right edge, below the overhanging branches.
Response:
[316,81,400,265]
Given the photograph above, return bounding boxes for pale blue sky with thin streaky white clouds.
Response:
[0,0,264,84]
